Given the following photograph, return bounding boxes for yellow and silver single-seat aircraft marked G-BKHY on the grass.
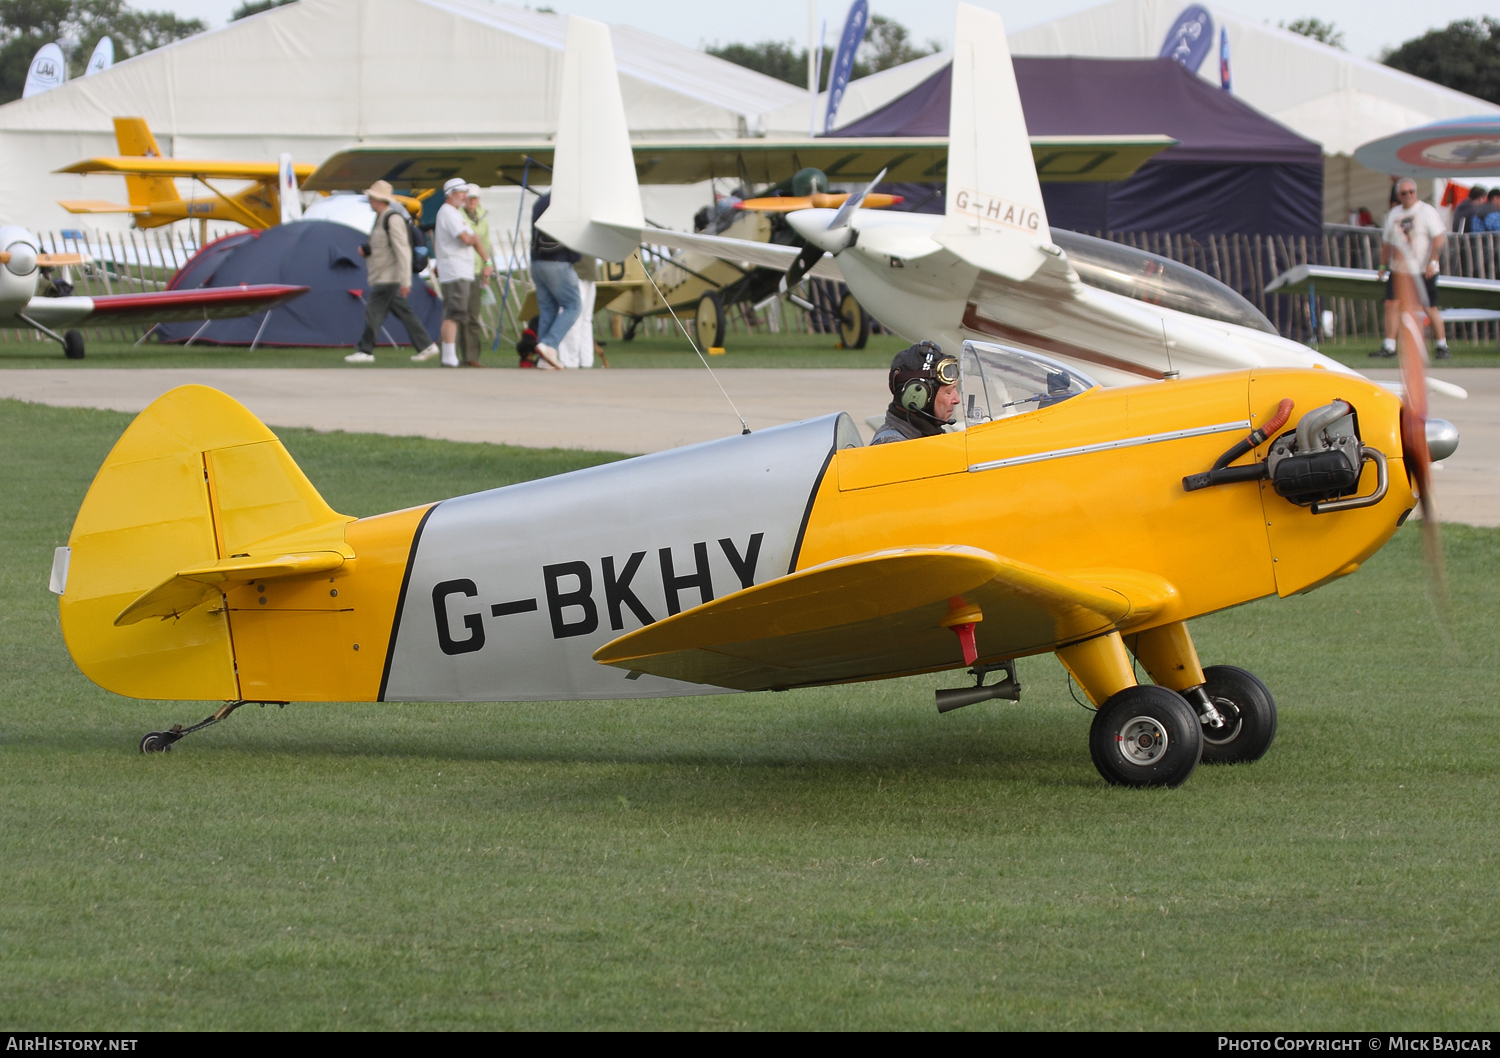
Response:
[51,9,1458,786]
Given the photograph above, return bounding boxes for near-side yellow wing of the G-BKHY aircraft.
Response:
[594,545,1175,690]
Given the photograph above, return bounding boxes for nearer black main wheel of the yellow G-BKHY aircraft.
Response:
[1089,684,1203,786]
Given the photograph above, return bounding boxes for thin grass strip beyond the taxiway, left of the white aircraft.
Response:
[0,332,900,371]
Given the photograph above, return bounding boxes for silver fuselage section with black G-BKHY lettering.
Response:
[381,416,858,701]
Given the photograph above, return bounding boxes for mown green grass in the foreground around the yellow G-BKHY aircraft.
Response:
[0,402,1500,1029]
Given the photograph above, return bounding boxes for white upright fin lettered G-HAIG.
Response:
[933,3,1052,282]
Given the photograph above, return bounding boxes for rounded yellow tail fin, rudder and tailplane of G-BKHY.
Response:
[53,386,354,699]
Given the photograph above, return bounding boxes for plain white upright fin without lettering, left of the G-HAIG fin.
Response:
[537,15,642,261]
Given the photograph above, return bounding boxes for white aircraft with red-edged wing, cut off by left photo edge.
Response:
[0,227,308,360]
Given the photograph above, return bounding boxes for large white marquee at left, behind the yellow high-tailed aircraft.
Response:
[0,0,807,230]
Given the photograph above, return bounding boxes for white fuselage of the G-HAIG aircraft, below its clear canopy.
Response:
[788,210,1353,386]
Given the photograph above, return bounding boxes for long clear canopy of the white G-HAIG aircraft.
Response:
[1052,228,1277,335]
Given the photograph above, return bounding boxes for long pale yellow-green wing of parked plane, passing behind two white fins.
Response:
[301,135,1178,191]
